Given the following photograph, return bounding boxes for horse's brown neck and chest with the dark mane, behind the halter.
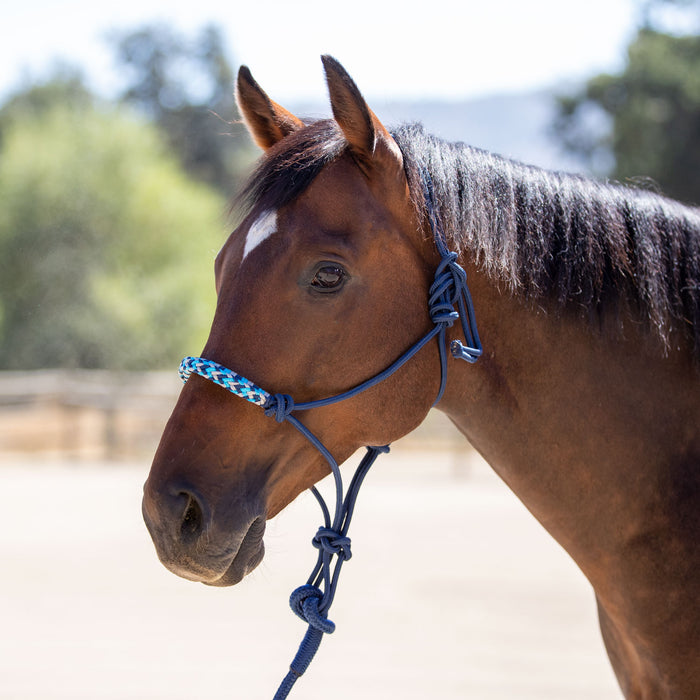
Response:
[408,129,700,697]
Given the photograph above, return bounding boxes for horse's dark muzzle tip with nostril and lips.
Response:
[142,479,265,586]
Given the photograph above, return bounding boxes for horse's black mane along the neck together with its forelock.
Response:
[242,120,700,355]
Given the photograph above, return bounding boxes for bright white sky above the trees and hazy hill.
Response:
[0,0,638,103]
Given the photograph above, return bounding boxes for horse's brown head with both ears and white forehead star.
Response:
[143,57,440,585]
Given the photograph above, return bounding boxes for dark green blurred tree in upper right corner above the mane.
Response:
[554,0,700,204]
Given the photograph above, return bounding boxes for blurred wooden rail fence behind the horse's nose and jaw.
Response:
[0,370,468,471]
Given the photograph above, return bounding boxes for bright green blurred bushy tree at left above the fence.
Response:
[0,100,224,369]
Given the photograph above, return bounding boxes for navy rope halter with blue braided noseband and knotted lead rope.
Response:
[180,173,482,700]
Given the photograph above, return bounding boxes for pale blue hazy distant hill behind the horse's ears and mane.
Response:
[289,92,583,172]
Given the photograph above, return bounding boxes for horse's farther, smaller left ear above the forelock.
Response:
[236,66,304,150]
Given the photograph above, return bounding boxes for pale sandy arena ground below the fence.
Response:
[0,450,621,700]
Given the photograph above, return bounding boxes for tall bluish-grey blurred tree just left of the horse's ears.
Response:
[111,24,256,193]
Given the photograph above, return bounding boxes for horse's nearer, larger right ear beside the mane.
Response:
[321,56,403,171]
